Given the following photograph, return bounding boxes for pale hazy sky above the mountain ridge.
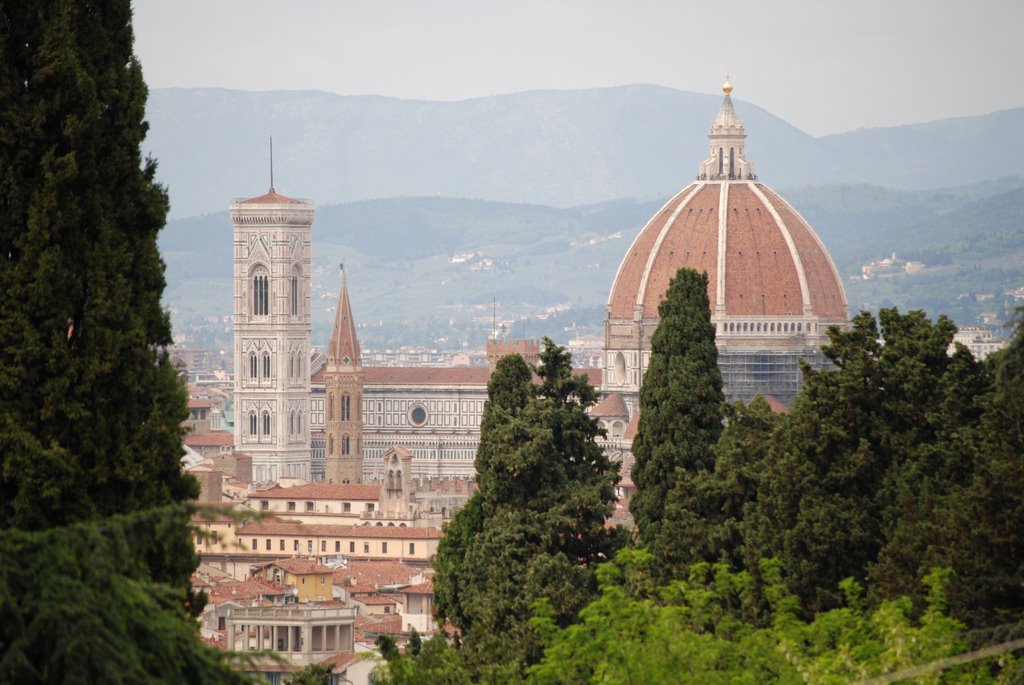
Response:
[135,0,1024,135]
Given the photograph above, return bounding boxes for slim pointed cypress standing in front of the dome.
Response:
[630,269,725,581]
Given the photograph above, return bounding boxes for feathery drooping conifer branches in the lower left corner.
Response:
[0,508,249,685]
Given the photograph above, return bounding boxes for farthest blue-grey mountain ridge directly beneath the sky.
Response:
[143,85,1024,218]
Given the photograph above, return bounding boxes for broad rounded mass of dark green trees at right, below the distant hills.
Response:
[741,309,1024,626]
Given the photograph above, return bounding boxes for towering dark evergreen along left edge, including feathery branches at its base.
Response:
[0,0,233,683]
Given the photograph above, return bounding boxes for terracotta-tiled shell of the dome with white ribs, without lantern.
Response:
[608,181,847,319]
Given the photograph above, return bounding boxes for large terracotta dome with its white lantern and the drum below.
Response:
[602,81,850,417]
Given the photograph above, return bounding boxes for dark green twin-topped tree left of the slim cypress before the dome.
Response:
[425,340,622,677]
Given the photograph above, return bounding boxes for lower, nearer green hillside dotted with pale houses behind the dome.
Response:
[160,177,1024,346]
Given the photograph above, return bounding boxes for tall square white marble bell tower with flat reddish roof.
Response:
[230,181,315,482]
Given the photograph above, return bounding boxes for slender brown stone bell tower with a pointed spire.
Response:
[324,265,362,483]
